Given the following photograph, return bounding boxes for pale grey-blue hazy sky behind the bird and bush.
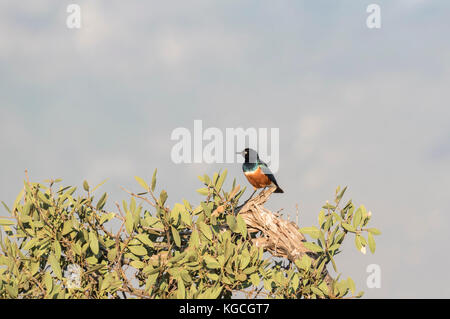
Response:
[0,0,450,298]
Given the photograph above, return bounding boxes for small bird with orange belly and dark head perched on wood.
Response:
[237,148,284,198]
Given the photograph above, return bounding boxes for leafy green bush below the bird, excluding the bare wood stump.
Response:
[0,170,379,298]
